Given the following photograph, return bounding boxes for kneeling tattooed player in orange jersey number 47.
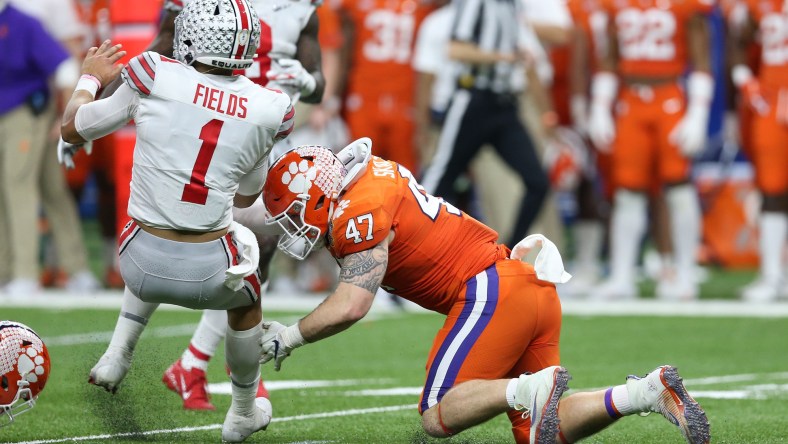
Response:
[261,138,709,443]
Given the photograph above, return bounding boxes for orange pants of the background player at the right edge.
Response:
[750,89,788,195]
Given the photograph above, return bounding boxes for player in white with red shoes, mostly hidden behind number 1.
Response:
[151,0,325,410]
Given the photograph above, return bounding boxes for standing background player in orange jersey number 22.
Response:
[589,0,714,299]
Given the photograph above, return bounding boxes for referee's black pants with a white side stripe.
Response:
[421,89,549,248]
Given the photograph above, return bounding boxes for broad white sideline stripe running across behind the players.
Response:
[0,290,788,318]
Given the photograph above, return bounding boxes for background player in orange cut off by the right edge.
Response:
[731,0,788,301]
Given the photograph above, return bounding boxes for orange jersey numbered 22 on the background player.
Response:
[603,0,714,77]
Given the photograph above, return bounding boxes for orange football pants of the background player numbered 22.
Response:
[613,83,691,191]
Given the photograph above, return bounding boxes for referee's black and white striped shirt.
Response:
[451,0,525,93]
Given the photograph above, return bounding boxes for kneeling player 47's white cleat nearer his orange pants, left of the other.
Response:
[514,366,572,444]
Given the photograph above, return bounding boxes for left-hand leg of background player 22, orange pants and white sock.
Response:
[590,90,656,300]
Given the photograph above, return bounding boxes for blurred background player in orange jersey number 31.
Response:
[326,0,438,174]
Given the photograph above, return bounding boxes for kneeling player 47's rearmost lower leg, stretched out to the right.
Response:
[556,365,710,444]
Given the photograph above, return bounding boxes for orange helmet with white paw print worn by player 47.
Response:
[263,145,347,260]
